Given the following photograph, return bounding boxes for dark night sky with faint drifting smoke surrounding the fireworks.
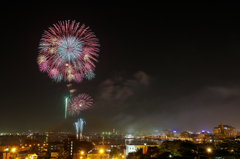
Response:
[0,1,240,132]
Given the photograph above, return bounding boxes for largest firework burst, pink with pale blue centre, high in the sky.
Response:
[37,21,99,83]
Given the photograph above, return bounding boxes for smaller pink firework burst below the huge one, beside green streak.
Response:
[67,93,93,116]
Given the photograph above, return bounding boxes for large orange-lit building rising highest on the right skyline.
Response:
[213,124,237,137]
